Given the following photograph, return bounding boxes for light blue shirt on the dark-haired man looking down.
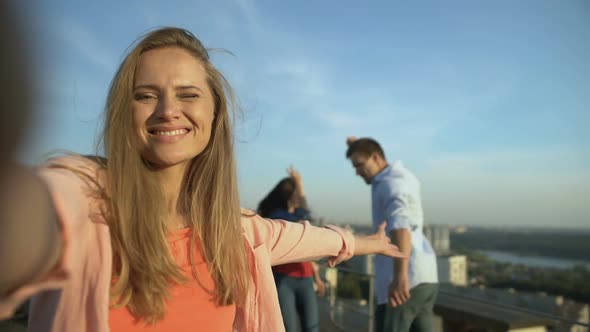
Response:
[371,161,438,304]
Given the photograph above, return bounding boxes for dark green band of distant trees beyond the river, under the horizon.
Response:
[451,230,590,260]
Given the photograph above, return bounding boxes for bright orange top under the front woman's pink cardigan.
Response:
[109,228,236,332]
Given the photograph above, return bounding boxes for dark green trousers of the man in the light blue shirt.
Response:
[375,284,438,332]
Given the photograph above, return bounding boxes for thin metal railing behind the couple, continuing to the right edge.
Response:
[318,263,590,332]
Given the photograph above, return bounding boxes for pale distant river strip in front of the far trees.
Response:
[478,250,590,269]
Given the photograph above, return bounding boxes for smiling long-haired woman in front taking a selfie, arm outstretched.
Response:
[0,28,410,332]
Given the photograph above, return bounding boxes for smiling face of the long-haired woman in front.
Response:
[131,47,215,168]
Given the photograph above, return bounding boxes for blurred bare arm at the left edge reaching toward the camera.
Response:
[0,165,61,296]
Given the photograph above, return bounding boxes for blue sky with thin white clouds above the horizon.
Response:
[18,0,590,227]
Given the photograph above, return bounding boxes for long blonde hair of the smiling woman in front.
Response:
[102,28,249,323]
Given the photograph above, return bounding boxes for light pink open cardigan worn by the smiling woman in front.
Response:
[0,157,354,332]
